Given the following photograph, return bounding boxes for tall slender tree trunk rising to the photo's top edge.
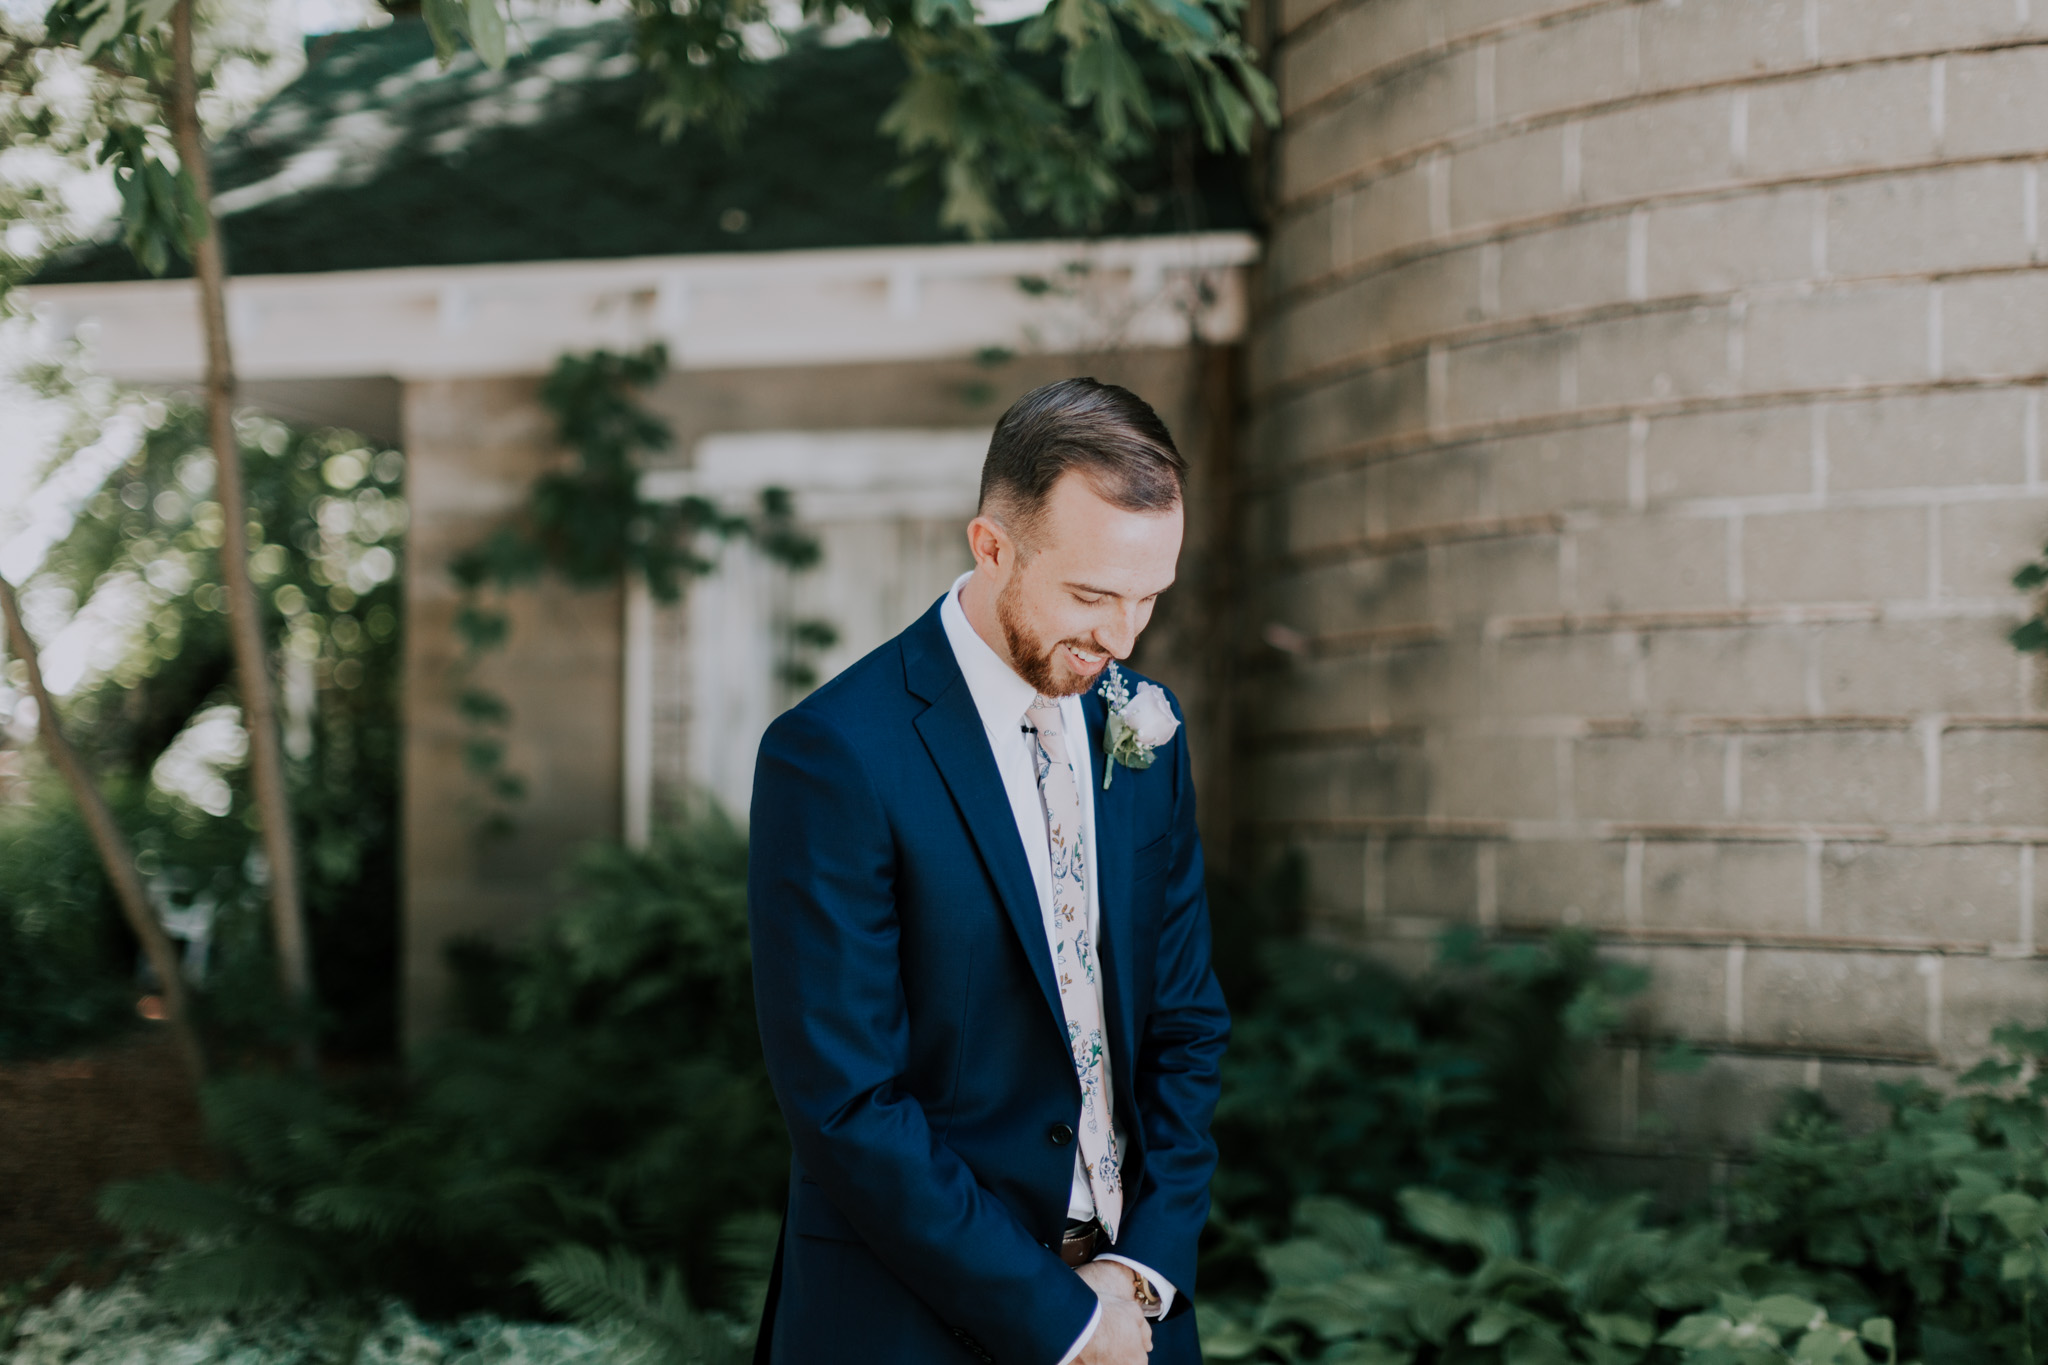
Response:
[168,0,315,1068]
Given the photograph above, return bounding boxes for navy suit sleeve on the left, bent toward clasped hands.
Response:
[748,706,1096,1365]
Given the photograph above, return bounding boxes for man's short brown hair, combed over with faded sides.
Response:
[981,379,1188,540]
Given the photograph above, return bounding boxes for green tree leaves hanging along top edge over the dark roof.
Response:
[45,0,1280,274]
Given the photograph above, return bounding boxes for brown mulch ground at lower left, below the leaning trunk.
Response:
[0,1025,213,1285]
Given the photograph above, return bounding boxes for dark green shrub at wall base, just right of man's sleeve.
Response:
[1214,933,1645,1232]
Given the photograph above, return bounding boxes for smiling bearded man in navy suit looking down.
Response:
[748,379,1229,1365]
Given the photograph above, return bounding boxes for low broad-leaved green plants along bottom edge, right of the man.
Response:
[1200,1189,1898,1365]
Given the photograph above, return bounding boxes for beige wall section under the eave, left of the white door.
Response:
[401,379,623,1040]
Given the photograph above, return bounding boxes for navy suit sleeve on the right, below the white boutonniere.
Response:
[1116,687,1231,1316]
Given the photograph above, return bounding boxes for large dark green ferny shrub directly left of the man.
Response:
[102,821,788,1318]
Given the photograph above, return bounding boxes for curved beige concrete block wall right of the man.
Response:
[1245,0,2048,1152]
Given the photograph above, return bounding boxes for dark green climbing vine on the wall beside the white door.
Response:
[451,344,840,833]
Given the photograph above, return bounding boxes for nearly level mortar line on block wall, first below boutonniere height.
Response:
[1247,814,2048,847]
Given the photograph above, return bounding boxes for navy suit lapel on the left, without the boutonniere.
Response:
[903,606,1067,1040]
